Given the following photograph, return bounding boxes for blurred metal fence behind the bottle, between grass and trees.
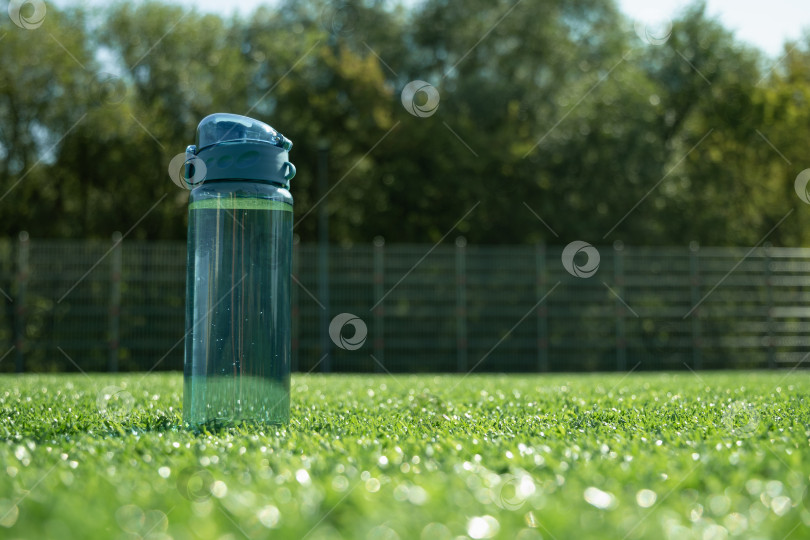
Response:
[0,233,810,372]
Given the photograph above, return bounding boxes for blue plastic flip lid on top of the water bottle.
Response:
[186,113,295,187]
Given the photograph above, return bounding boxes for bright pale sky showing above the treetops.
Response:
[52,0,810,57]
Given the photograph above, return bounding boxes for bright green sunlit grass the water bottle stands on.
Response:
[0,372,810,540]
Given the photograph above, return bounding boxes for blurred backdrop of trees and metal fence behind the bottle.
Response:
[0,0,810,371]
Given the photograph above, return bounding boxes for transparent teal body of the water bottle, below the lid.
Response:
[183,180,292,426]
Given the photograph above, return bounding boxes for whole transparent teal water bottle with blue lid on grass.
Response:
[183,113,295,427]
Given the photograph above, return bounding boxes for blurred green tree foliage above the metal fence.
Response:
[0,0,810,245]
